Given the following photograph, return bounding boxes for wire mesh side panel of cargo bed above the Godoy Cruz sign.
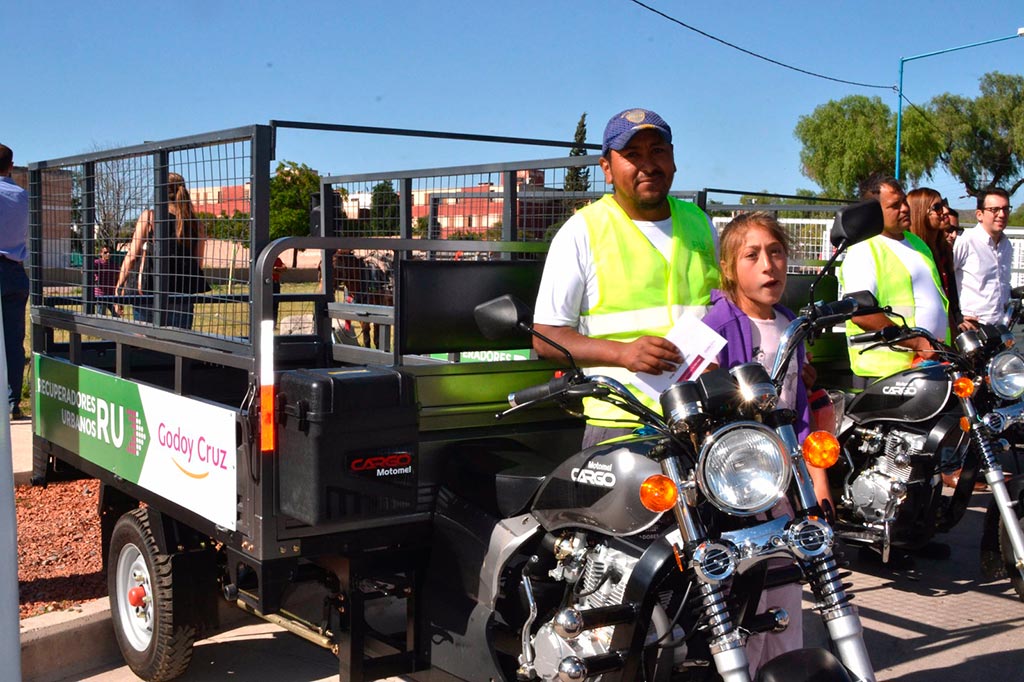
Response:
[33,139,252,338]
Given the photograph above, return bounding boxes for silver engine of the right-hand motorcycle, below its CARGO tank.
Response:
[848,429,928,521]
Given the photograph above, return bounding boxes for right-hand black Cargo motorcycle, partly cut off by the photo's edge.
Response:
[802,272,1024,599]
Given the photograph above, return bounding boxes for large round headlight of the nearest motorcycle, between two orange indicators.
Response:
[697,422,791,516]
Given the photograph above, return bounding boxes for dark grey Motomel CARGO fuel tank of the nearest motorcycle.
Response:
[532,438,662,536]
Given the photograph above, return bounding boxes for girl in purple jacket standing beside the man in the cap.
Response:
[703,212,831,677]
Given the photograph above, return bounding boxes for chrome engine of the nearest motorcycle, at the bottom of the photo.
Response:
[534,545,685,681]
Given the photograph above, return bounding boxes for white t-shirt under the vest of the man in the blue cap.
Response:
[534,205,719,329]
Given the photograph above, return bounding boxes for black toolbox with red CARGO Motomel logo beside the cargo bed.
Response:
[276,367,421,527]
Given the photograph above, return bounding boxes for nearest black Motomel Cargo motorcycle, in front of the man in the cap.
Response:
[427,202,882,682]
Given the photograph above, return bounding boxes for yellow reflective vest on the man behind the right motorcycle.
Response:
[840,231,949,377]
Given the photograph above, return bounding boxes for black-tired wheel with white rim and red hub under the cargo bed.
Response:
[106,509,196,682]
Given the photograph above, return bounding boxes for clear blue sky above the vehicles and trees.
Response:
[0,0,1024,206]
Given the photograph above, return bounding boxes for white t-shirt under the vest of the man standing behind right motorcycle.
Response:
[843,237,949,341]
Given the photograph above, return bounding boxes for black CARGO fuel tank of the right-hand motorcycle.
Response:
[846,365,952,424]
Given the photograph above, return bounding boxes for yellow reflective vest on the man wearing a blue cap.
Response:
[580,195,719,427]
